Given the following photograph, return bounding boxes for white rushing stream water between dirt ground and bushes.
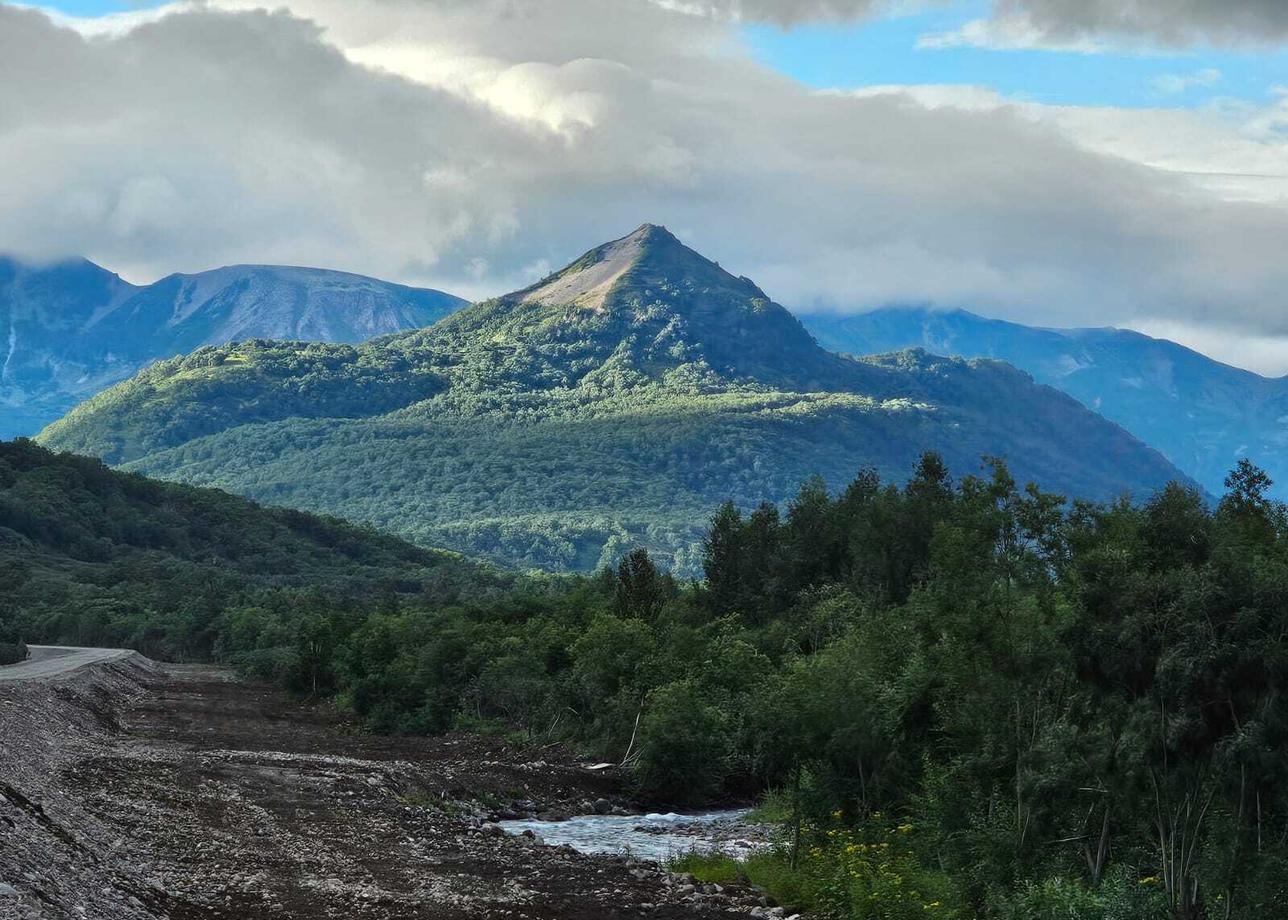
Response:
[498,809,765,862]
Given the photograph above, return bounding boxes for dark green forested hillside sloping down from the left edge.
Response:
[0,439,515,658]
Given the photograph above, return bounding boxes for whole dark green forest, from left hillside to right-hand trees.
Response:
[0,432,1288,920]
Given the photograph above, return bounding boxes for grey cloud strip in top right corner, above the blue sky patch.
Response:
[922,0,1288,52]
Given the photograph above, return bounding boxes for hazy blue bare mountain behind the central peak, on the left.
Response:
[0,251,465,438]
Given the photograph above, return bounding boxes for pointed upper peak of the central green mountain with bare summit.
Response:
[425,223,863,389]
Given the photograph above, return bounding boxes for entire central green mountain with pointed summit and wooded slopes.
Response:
[32,224,1184,572]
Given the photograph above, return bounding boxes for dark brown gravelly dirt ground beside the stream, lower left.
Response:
[0,658,769,920]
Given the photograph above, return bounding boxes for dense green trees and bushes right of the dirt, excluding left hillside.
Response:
[294,455,1288,920]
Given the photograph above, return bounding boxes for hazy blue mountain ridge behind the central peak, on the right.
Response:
[802,308,1288,497]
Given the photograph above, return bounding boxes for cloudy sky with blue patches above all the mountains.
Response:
[0,0,1288,374]
